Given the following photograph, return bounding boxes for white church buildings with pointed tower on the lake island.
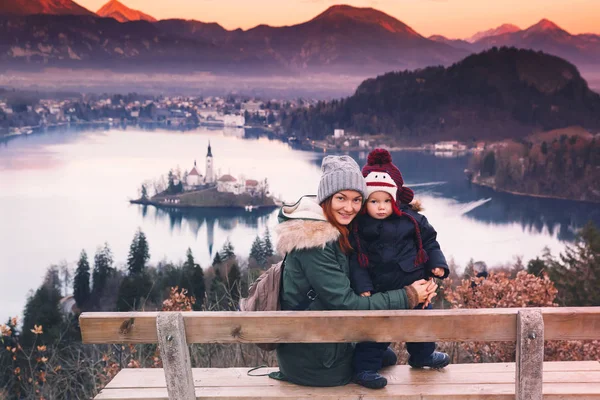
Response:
[183,142,269,196]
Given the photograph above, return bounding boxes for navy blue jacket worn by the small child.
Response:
[350,205,450,294]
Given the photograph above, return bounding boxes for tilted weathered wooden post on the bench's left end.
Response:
[156,312,196,400]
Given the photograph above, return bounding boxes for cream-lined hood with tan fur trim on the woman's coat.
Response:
[275,196,340,255]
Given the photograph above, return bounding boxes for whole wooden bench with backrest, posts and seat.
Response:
[80,307,600,400]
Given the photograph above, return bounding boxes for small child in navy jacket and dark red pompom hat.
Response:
[350,149,450,389]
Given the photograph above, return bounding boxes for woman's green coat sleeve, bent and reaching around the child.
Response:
[298,246,408,310]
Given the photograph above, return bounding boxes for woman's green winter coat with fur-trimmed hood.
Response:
[272,196,408,386]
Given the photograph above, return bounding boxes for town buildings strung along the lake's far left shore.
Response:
[0,94,312,135]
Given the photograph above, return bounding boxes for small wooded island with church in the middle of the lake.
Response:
[130,142,281,211]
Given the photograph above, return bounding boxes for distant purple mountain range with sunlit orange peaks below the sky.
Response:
[0,0,600,75]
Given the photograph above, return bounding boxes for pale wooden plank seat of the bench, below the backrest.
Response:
[96,361,600,400]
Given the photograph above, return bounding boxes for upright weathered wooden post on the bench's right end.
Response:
[515,309,544,400]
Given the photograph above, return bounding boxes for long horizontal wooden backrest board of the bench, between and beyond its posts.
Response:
[80,307,600,344]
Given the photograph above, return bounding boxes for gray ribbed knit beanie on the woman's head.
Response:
[317,156,367,204]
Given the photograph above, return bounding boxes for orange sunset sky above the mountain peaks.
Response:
[75,0,600,39]
